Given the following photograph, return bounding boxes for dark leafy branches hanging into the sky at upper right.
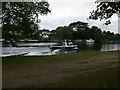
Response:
[89,0,120,25]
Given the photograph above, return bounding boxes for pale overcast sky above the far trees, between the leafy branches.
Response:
[39,0,118,33]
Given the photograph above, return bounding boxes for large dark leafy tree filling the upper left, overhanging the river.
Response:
[2,1,51,44]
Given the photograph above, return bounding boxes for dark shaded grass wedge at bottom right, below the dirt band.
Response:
[21,67,119,88]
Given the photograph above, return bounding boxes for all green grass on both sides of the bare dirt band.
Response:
[2,51,120,88]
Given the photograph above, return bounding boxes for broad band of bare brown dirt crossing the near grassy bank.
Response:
[3,54,118,88]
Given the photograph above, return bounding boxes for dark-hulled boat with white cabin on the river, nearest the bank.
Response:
[49,40,78,51]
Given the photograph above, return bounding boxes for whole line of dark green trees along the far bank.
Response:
[50,21,120,42]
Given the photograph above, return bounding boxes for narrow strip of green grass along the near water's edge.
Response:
[2,51,120,66]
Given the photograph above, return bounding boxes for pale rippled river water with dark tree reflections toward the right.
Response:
[0,42,120,57]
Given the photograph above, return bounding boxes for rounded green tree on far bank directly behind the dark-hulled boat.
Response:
[56,26,73,40]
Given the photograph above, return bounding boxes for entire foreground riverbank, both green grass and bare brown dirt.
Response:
[3,51,120,88]
